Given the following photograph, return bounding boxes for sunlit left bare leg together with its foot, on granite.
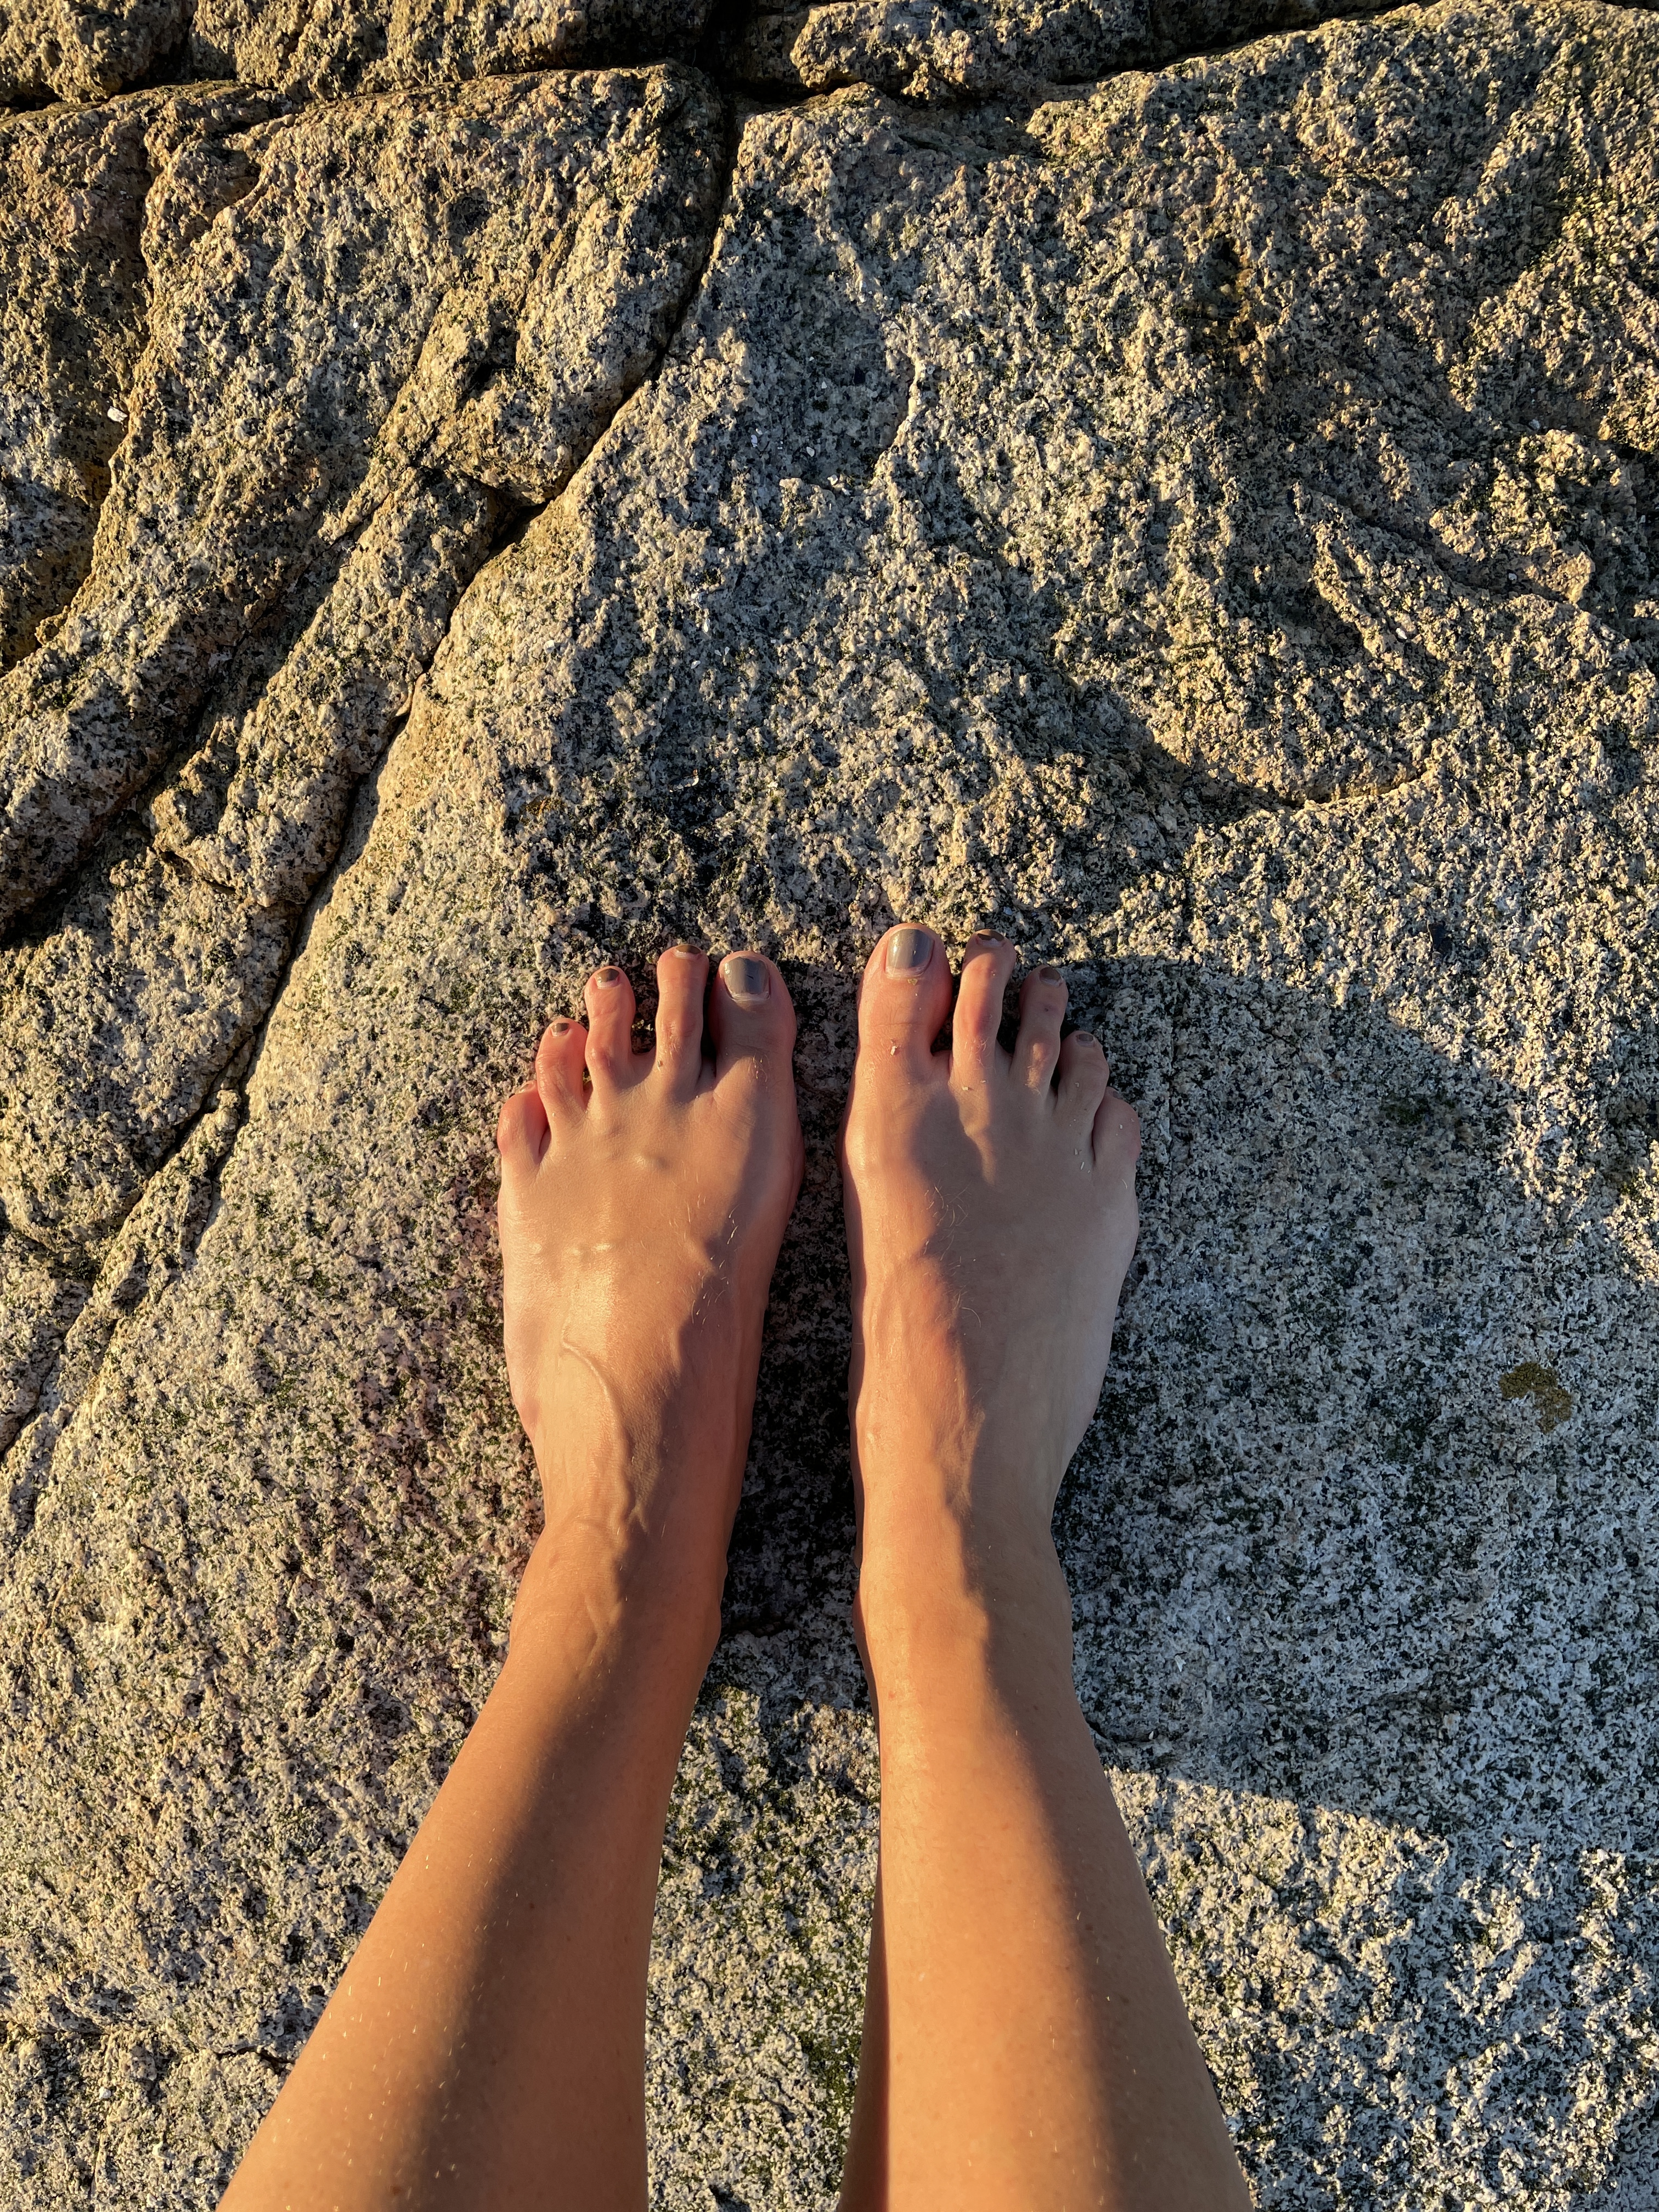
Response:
[225,947,801,2212]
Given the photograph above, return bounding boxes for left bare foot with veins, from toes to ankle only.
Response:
[495,945,801,1633]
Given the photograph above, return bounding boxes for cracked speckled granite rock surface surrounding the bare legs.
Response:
[0,0,1659,2212]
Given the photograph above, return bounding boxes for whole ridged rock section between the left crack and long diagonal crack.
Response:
[0,71,721,1250]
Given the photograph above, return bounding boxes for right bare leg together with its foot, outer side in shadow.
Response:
[843,929,1250,2212]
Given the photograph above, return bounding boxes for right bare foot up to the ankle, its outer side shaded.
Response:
[843,929,1139,1608]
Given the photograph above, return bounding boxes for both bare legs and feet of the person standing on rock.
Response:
[223,931,1248,2212]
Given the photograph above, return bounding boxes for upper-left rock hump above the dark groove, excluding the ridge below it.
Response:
[0,73,716,916]
